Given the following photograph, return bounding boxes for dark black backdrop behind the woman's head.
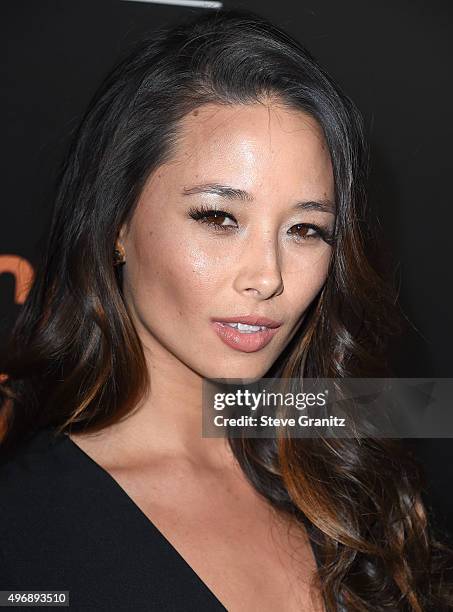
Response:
[0,0,453,532]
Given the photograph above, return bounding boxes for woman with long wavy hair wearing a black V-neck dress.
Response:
[0,11,453,611]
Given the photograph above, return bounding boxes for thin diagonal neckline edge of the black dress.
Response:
[50,428,228,612]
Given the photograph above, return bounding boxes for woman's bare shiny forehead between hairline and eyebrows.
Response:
[142,103,334,207]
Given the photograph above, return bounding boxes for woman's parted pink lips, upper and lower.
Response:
[211,315,281,353]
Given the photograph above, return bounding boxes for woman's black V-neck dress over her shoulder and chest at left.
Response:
[0,428,322,612]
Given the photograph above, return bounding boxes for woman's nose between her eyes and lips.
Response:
[234,233,283,300]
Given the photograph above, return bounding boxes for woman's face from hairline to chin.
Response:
[120,103,334,379]
